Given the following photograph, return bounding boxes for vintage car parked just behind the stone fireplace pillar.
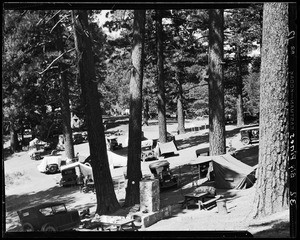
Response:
[149,160,178,189]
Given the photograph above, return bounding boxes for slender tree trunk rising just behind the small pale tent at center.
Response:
[156,10,167,143]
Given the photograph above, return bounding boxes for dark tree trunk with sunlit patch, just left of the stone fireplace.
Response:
[125,10,146,206]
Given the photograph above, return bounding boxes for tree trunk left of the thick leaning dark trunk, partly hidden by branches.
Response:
[54,14,74,159]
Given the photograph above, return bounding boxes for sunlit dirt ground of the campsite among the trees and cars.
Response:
[4,123,290,238]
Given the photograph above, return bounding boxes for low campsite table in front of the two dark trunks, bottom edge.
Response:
[92,219,137,231]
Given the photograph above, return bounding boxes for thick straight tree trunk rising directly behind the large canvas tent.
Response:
[208,9,226,155]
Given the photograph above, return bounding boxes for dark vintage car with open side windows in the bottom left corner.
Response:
[17,202,80,232]
